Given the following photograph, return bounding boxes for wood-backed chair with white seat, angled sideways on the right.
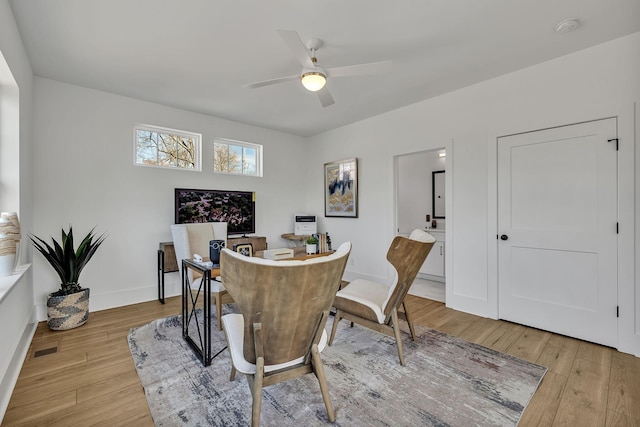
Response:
[329,229,436,366]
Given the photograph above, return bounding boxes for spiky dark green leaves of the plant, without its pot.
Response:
[29,226,106,296]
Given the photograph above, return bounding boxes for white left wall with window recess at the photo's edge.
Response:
[0,0,35,420]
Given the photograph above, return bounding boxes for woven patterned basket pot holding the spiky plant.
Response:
[47,288,89,331]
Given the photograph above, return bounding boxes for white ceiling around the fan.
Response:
[10,0,640,136]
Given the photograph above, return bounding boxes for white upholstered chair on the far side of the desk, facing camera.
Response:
[171,222,233,330]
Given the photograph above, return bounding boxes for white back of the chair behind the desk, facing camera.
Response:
[171,222,227,281]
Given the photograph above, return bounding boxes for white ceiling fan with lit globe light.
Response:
[245,30,391,107]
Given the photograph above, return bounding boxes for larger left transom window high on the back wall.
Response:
[134,125,202,171]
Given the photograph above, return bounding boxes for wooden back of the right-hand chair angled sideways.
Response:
[383,229,436,323]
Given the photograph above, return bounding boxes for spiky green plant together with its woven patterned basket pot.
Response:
[29,226,106,331]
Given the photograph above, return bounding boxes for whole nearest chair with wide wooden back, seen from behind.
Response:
[220,242,351,426]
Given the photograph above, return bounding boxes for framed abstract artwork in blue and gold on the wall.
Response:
[324,157,358,218]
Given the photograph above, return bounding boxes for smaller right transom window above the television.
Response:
[213,139,262,176]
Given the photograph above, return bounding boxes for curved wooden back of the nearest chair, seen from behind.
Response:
[220,242,351,365]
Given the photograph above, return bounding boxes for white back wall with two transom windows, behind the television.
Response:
[29,78,307,319]
